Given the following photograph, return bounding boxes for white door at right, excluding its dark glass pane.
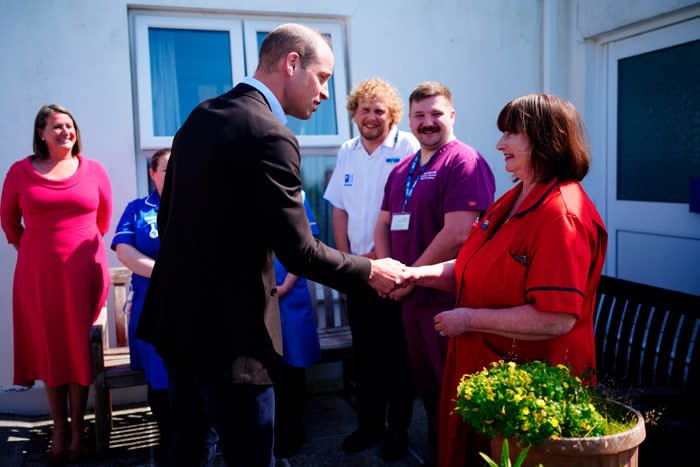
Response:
[600,17,700,291]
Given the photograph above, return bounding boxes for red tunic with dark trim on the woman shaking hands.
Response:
[438,181,607,467]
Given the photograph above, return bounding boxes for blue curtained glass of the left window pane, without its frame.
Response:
[148,28,232,136]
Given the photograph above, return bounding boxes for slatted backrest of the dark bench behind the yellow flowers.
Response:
[594,276,700,390]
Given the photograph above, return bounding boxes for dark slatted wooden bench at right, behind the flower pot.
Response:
[594,276,700,465]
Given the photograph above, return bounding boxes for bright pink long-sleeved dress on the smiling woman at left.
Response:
[0,155,112,387]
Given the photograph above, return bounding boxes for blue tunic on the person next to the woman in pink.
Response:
[111,191,168,389]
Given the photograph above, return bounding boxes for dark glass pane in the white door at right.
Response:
[617,40,700,204]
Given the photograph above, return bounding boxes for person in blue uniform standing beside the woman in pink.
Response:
[111,149,170,457]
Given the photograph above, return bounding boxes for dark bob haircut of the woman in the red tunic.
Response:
[497,94,591,182]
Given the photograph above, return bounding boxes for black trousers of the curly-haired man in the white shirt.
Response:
[347,286,414,433]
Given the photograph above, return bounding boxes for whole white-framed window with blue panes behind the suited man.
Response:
[131,11,350,244]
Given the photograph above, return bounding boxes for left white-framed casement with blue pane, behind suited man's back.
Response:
[134,15,246,150]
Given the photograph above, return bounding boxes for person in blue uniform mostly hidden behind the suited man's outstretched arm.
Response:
[274,190,321,458]
